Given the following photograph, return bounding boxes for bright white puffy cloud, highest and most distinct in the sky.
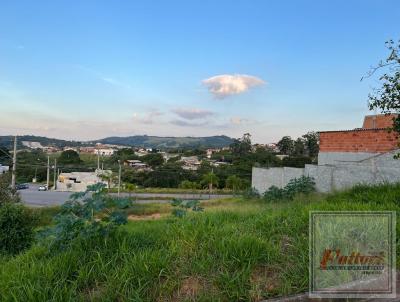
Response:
[202,74,265,99]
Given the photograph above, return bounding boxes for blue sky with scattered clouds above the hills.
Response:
[0,0,400,143]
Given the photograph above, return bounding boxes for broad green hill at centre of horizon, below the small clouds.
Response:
[96,135,233,149]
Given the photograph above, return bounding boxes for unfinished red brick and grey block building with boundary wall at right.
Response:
[252,114,400,193]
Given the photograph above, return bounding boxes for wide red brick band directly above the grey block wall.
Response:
[319,129,399,153]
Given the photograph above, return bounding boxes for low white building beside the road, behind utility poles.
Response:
[57,170,112,192]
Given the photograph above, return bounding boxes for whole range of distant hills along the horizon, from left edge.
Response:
[0,135,233,149]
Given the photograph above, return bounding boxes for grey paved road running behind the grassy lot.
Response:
[19,184,232,207]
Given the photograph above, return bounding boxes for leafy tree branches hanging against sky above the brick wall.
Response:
[368,40,400,133]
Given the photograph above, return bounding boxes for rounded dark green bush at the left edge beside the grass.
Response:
[0,203,35,255]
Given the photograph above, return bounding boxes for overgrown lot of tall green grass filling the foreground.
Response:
[0,185,400,301]
